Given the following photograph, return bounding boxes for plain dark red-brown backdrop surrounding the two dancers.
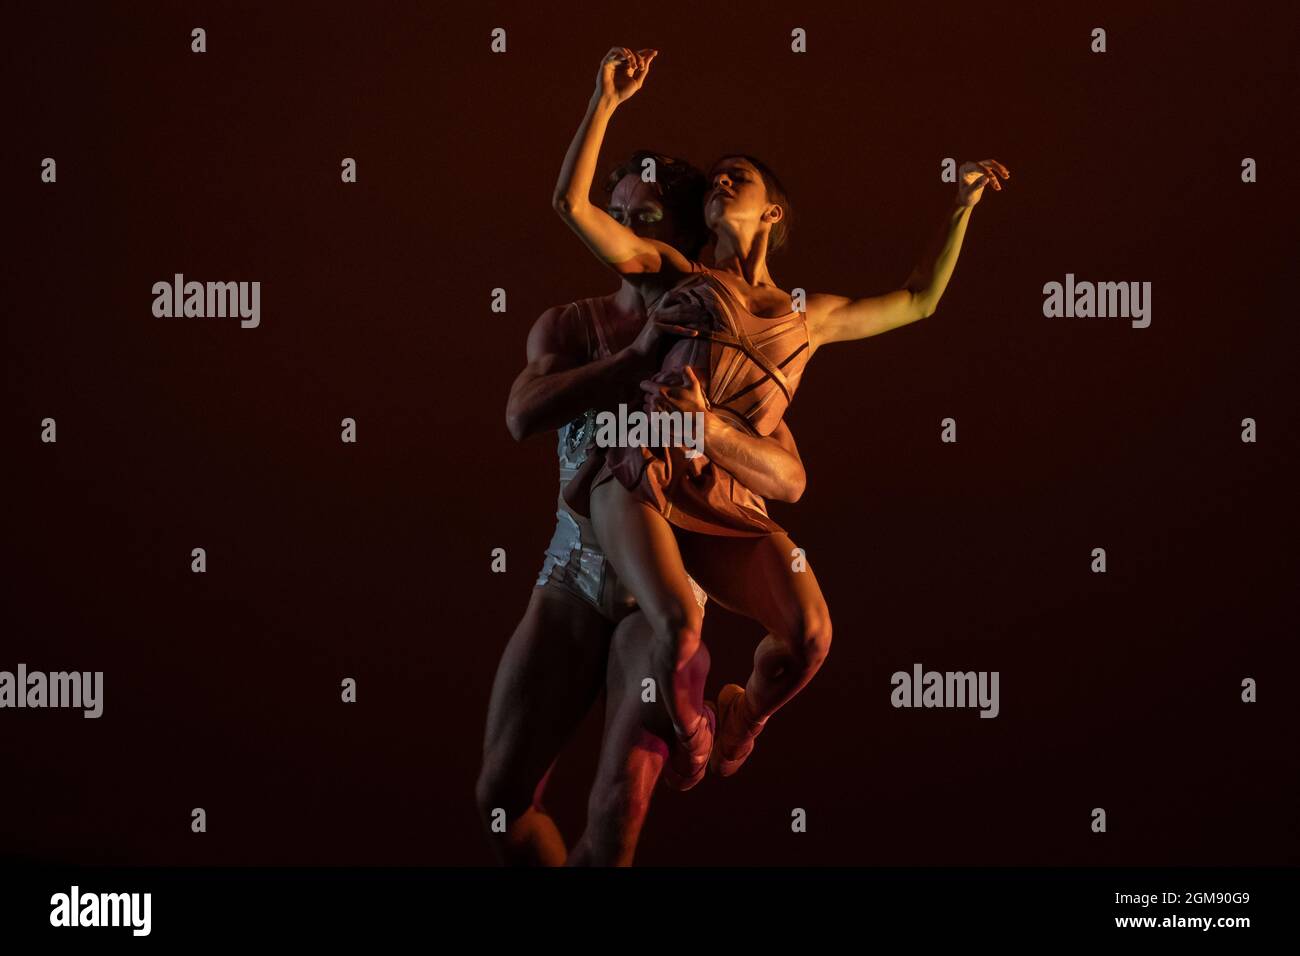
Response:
[0,3,1300,864]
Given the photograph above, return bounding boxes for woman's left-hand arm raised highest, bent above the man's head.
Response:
[551,47,690,276]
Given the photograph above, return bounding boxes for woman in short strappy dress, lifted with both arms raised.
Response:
[554,47,1010,787]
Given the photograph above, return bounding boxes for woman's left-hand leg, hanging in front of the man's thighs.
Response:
[592,481,712,786]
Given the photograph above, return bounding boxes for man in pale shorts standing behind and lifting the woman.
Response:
[476,152,805,865]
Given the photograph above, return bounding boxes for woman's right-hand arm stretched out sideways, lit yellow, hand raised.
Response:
[807,160,1010,350]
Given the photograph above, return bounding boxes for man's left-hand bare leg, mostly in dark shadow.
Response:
[475,584,612,866]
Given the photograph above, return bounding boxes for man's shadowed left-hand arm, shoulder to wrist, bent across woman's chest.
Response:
[506,306,659,441]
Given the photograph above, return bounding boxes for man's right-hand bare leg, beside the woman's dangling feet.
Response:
[568,611,709,866]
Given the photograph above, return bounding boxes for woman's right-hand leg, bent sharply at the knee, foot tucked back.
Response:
[679,533,831,777]
